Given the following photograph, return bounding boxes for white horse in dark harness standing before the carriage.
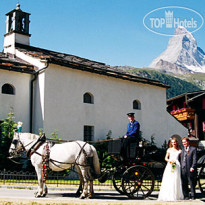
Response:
[9,133,101,198]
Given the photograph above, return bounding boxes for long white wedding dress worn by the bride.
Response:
[158,148,184,201]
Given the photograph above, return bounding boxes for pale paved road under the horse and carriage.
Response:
[0,187,205,205]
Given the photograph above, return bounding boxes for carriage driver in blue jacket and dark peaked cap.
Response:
[121,112,140,160]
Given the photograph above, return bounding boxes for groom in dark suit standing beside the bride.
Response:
[181,137,197,200]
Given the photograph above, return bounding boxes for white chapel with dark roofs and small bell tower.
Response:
[0,4,187,146]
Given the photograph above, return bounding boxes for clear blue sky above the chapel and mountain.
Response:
[0,0,205,68]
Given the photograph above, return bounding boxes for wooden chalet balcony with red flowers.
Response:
[170,108,195,121]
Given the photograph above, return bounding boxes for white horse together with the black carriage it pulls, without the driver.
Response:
[9,133,205,199]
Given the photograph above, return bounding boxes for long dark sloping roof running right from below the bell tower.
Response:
[15,43,169,88]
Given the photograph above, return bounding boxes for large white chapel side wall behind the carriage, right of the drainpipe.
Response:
[32,64,189,146]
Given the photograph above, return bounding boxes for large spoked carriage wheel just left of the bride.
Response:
[122,165,154,199]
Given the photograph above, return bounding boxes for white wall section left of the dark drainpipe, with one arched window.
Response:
[0,69,31,132]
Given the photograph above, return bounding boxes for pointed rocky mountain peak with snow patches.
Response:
[149,26,205,74]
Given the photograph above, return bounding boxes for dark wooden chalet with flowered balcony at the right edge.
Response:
[167,90,205,144]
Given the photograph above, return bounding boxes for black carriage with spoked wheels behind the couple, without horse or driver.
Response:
[99,140,205,199]
